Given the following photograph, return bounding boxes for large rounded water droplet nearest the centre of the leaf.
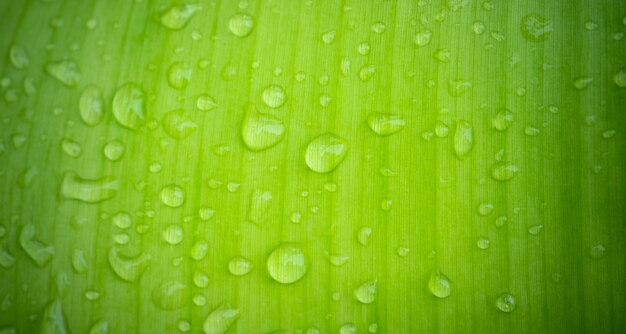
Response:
[305,133,348,173]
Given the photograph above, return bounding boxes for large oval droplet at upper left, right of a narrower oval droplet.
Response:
[113,83,145,130]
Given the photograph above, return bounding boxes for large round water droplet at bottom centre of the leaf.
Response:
[267,243,309,284]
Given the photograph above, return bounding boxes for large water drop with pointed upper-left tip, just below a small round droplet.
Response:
[241,104,285,152]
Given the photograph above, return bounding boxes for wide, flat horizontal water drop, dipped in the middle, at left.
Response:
[61,172,119,203]
